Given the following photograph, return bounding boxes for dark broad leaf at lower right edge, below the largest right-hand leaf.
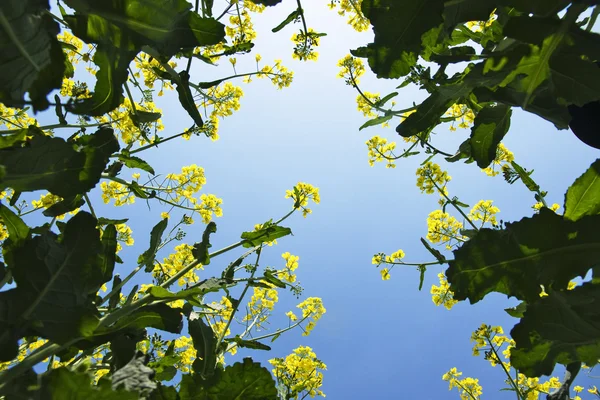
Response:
[510,283,600,377]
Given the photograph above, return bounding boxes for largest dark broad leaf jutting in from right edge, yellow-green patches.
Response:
[446,208,600,303]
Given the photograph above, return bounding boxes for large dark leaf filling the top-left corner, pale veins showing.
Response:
[0,0,65,111]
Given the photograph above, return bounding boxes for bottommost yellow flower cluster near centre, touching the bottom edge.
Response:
[269,346,327,398]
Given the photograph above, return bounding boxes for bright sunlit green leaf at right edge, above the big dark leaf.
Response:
[564,159,600,221]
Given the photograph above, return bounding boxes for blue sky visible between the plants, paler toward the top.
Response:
[27,2,600,400]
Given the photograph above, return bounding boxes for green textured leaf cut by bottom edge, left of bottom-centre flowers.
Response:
[179,358,277,400]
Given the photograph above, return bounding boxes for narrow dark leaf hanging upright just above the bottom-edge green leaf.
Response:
[188,314,217,378]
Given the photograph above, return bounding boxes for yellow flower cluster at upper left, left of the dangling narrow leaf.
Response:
[97,97,165,145]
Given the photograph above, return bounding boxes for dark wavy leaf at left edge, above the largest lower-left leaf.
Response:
[0,128,119,198]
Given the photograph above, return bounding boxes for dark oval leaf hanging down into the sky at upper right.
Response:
[470,104,512,168]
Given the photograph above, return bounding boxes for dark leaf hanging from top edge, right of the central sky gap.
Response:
[353,0,444,78]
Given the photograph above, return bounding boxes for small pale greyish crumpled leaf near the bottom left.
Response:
[112,351,156,397]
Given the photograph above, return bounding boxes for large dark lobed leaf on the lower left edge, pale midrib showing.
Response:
[0,212,105,361]
